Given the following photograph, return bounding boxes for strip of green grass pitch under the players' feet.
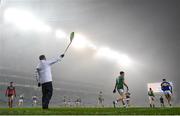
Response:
[0,107,180,115]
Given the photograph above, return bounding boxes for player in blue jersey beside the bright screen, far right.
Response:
[161,79,172,106]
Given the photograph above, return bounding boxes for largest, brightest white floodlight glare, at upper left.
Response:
[4,8,51,32]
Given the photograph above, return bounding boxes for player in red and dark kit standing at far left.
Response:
[5,82,16,108]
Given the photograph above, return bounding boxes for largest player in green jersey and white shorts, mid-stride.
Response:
[113,71,129,107]
